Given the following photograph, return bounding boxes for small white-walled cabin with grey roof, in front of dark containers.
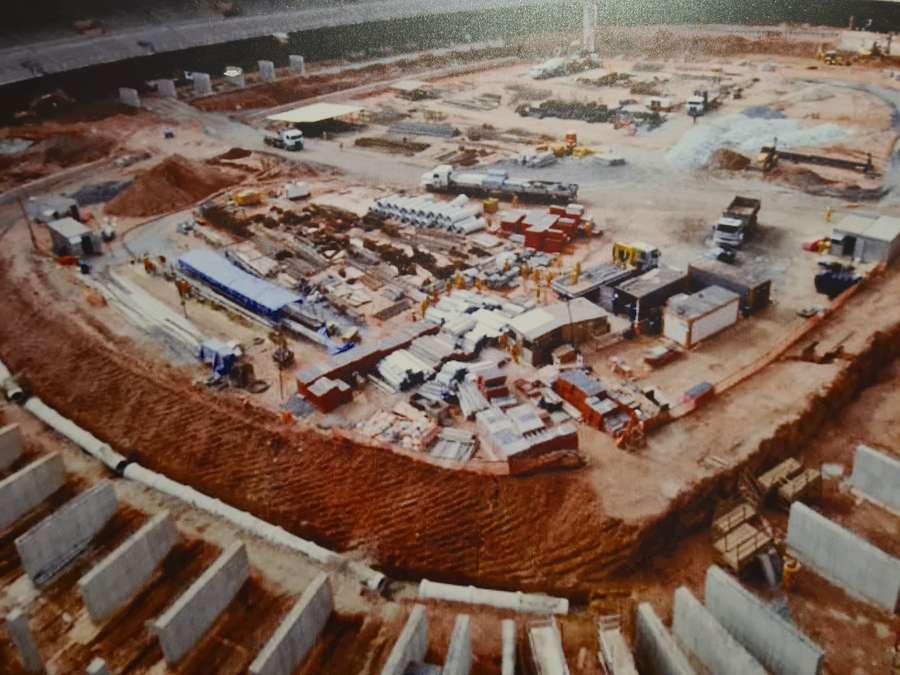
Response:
[663,286,741,349]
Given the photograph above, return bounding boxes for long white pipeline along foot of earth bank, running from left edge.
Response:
[0,361,387,591]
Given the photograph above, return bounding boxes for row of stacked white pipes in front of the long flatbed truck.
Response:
[370,194,487,234]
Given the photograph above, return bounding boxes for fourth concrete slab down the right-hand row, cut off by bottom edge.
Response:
[672,586,766,675]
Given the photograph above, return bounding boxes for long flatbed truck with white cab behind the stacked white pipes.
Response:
[421,164,578,203]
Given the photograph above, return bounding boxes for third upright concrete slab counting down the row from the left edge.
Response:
[16,481,119,584]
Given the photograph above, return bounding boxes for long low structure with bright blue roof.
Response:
[178,249,303,319]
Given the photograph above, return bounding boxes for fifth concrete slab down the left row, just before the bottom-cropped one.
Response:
[150,542,250,665]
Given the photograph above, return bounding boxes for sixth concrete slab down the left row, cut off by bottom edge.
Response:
[250,573,334,675]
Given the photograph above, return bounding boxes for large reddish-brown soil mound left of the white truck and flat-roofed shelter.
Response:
[106,155,238,218]
